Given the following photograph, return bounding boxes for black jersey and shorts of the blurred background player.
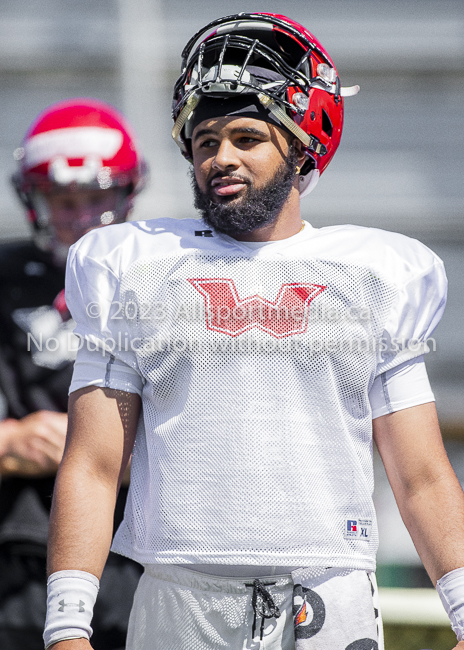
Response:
[0,242,142,650]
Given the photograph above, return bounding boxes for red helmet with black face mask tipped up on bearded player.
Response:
[172,13,359,196]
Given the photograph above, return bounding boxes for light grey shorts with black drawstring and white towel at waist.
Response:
[126,565,383,650]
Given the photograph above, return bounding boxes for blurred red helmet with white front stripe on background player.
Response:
[12,98,147,241]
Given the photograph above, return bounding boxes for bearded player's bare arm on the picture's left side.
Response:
[48,387,140,650]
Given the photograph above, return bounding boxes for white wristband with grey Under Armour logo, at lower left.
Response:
[43,571,100,648]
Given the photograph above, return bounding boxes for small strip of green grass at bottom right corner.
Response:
[384,625,456,650]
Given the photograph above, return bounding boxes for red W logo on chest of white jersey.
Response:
[188,278,327,339]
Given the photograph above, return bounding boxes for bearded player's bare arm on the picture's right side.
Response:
[373,402,464,650]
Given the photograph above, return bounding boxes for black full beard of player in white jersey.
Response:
[190,146,298,237]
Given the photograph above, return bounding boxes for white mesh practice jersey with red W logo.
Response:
[66,219,446,570]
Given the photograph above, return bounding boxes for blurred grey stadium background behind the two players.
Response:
[0,0,464,650]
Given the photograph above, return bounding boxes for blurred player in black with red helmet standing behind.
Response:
[0,99,147,650]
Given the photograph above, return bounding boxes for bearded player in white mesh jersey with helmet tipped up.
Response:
[44,13,464,650]
